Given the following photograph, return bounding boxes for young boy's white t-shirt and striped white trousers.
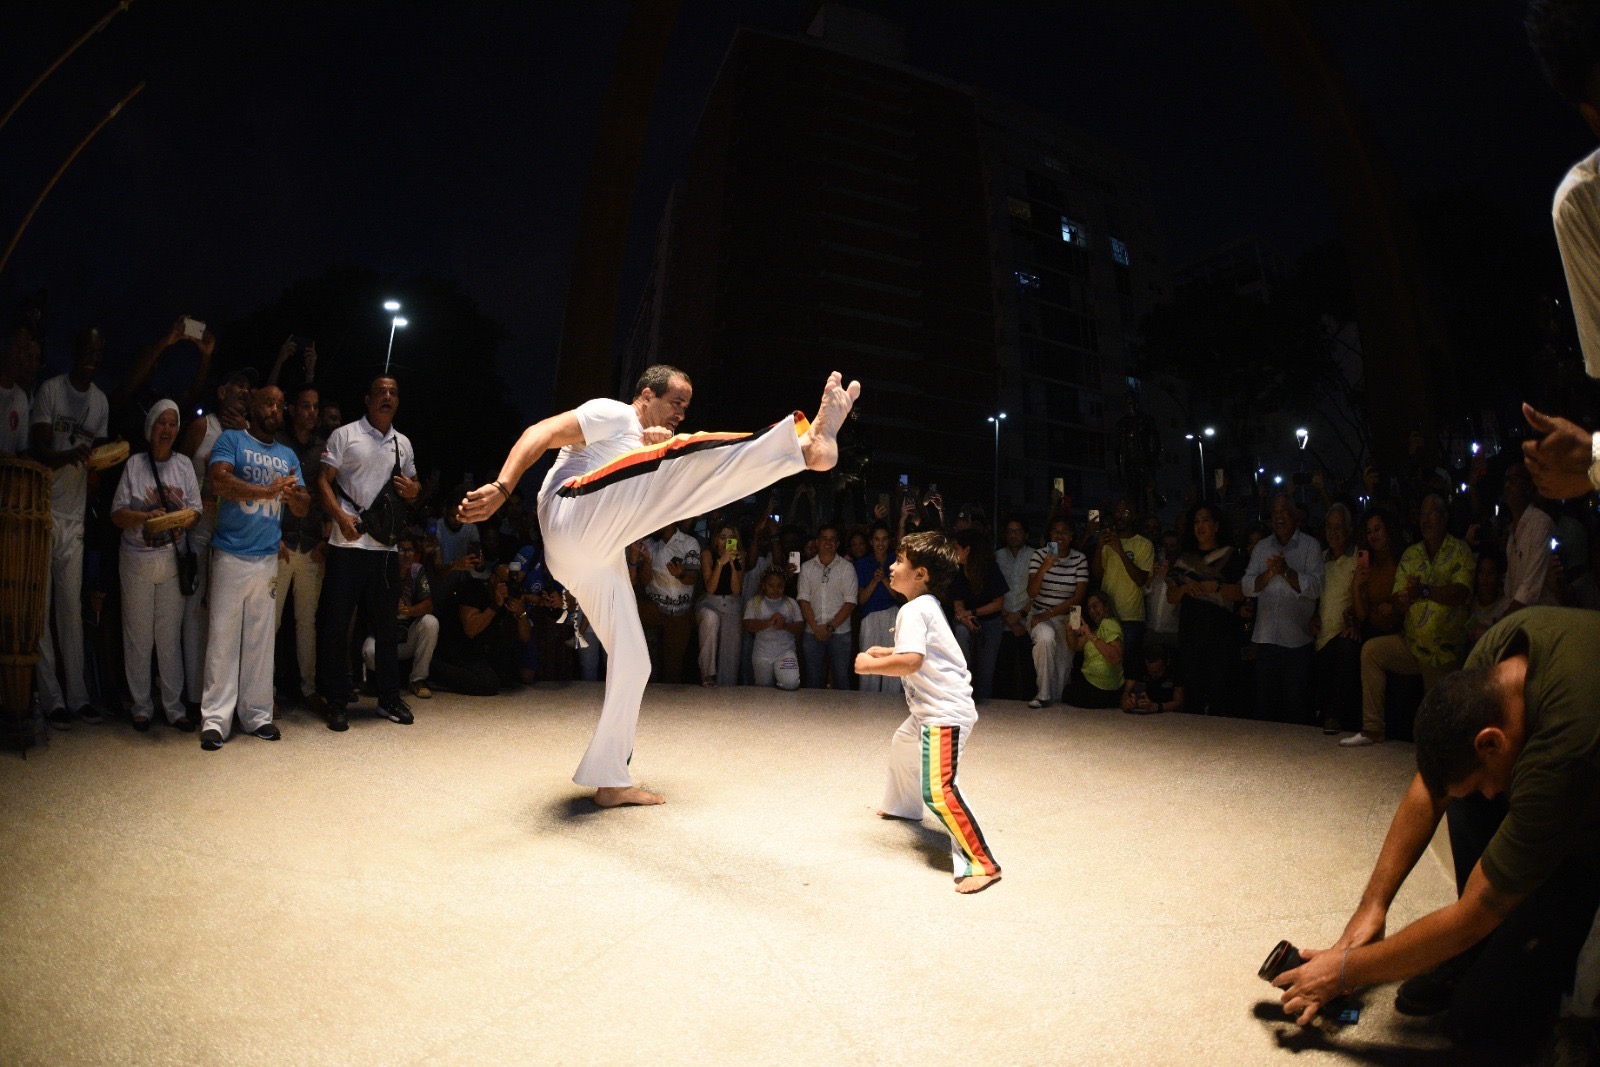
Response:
[883,593,1000,881]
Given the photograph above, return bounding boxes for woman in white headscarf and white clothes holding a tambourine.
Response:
[110,400,200,731]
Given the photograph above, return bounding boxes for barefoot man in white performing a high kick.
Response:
[461,363,861,808]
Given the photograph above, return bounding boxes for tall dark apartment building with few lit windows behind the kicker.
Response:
[619,5,1165,524]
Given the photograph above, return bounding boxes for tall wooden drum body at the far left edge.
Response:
[0,458,51,715]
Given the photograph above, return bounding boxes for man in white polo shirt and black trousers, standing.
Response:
[317,374,422,729]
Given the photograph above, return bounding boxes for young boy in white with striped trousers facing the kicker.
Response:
[856,531,1000,893]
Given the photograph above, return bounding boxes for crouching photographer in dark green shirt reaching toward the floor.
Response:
[1272,608,1600,1048]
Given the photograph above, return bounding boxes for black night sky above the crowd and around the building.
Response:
[0,0,1592,421]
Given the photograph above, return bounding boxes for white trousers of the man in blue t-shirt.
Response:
[200,550,278,739]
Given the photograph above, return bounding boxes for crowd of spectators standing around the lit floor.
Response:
[0,300,1600,747]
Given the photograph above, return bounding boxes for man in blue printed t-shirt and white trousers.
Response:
[200,386,310,752]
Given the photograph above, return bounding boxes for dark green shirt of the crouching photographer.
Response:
[1467,608,1600,894]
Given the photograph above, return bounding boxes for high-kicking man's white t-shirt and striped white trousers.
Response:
[539,400,808,787]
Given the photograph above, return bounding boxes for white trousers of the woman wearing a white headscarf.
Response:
[117,547,186,723]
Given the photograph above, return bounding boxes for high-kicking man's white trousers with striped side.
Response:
[539,419,805,787]
